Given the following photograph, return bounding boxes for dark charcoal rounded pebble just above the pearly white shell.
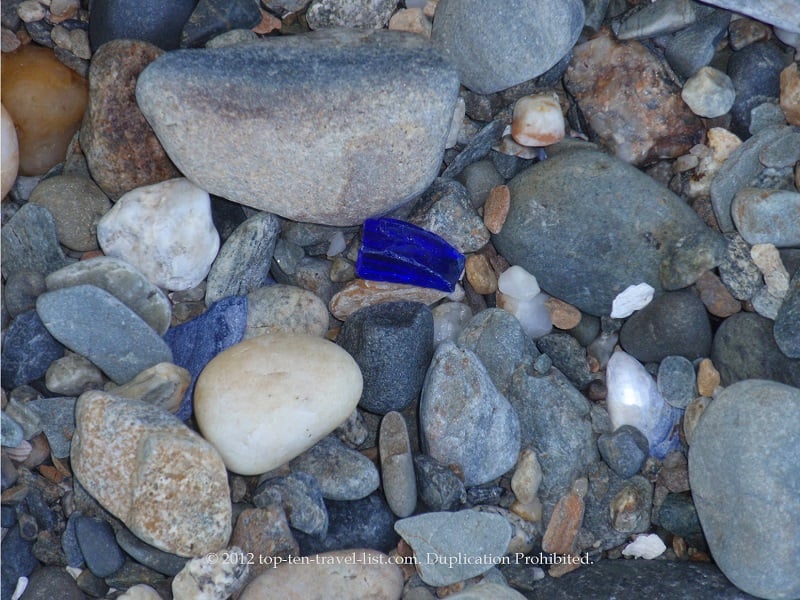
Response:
[619,291,712,362]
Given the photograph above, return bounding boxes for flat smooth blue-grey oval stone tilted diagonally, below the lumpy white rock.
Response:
[36,285,172,384]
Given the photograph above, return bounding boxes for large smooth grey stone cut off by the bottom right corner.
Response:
[689,380,800,598]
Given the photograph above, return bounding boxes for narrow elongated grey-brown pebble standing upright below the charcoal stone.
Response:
[378,412,417,519]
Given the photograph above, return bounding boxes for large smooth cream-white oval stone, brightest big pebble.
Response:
[194,334,363,475]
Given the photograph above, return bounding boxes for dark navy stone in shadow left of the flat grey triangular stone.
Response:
[293,492,398,555]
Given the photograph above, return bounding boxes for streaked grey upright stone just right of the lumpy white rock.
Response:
[206,213,280,306]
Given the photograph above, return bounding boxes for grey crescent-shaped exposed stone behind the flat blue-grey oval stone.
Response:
[45,256,172,335]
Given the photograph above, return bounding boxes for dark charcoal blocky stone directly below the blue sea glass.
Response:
[336,302,434,415]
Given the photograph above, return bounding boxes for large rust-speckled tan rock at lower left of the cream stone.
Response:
[71,391,231,556]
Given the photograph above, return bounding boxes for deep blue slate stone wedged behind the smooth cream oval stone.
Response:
[164,296,247,421]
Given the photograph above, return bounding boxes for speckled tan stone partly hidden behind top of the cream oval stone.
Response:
[243,283,329,340]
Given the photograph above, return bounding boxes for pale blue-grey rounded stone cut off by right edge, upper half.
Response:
[731,188,800,248]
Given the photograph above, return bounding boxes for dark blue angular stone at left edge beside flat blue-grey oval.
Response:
[0,310,64,389]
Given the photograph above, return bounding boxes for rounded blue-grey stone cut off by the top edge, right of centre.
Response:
[431,0,584,94]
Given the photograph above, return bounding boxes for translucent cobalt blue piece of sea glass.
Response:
[356,218,464,292]
